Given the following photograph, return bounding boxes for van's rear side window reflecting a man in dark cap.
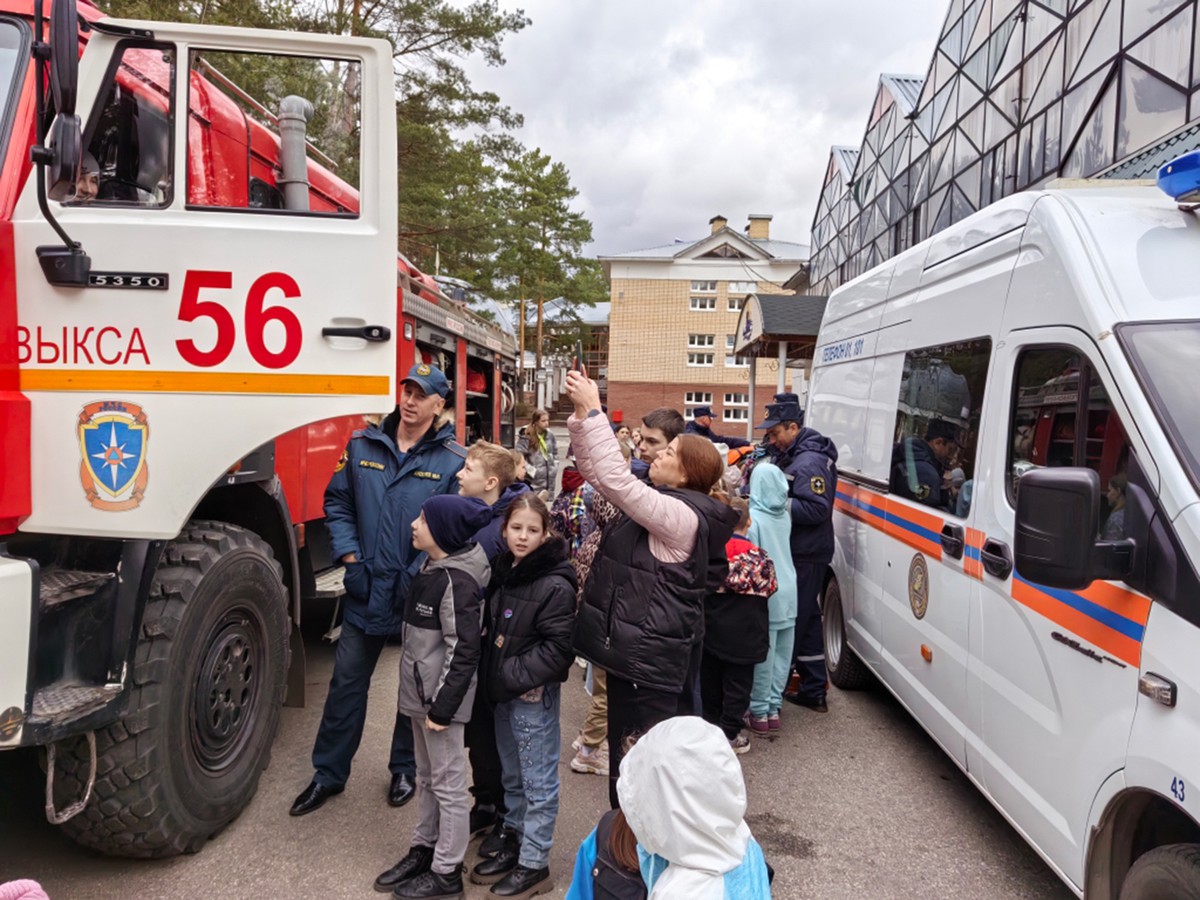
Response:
[889,338,991,516]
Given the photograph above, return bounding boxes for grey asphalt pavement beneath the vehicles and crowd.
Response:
[0,619,1072,900]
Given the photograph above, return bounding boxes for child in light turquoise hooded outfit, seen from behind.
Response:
[746,460,797,737]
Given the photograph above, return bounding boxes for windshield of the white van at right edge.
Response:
[1117,322,1200,490]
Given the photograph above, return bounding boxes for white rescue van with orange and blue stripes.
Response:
[806,155,1200,900]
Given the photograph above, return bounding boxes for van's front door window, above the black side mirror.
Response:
[1008,347,1129,540]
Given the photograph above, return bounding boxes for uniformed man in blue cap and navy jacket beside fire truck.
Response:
[292,364,466,816]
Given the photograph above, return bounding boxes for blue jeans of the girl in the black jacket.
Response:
[496,682,562,869]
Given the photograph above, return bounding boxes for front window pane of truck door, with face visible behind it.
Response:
[73,42,175,209]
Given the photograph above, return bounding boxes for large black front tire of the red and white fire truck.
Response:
[55,521,289,858]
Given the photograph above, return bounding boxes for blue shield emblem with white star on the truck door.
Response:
[76,400,150,512]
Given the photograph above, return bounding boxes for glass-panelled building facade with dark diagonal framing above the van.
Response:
[808,0,1200,294]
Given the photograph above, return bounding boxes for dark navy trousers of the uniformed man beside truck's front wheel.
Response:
[312,622,416,787]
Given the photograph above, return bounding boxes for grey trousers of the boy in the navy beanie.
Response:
[412,722,470,875]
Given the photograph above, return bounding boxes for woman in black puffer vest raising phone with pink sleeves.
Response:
[566,372,738,808]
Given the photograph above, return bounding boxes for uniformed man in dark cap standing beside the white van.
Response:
[758,394,838,713]
